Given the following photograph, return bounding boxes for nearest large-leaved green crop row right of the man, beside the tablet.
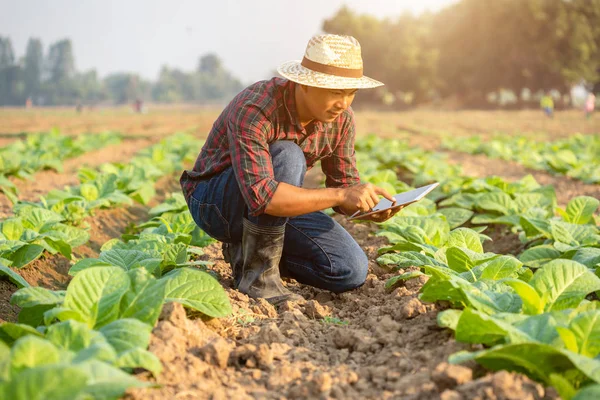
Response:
[357,137,600,399]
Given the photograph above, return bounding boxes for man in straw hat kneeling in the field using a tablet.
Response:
[180,35,398,304]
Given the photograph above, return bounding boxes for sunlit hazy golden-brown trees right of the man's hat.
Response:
[323,0,600,106]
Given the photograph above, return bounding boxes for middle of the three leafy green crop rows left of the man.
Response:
[0,134,199,268]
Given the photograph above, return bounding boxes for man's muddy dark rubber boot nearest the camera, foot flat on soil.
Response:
[238,218,303,304]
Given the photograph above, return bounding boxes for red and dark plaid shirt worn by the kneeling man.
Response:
[180,78,360,215]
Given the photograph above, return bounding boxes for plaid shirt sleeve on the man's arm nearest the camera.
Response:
[227,105,278,216]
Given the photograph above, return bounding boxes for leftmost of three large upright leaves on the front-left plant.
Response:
[63,267,130,328]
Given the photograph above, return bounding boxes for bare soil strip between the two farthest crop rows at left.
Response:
[0,138,158,218]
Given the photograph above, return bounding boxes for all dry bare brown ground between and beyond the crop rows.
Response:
[0,109,600,400]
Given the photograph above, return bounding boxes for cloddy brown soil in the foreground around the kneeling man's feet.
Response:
[126,211,557,400]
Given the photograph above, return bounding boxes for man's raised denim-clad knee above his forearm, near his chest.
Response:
[269,140,306,186]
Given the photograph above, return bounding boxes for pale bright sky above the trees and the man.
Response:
[0,0,457,83]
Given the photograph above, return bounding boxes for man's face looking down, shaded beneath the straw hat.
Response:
[305,86,358,122]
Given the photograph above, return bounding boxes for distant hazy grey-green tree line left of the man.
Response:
[0,36,242,106]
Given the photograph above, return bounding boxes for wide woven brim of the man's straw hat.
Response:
[277,60,383,89]
